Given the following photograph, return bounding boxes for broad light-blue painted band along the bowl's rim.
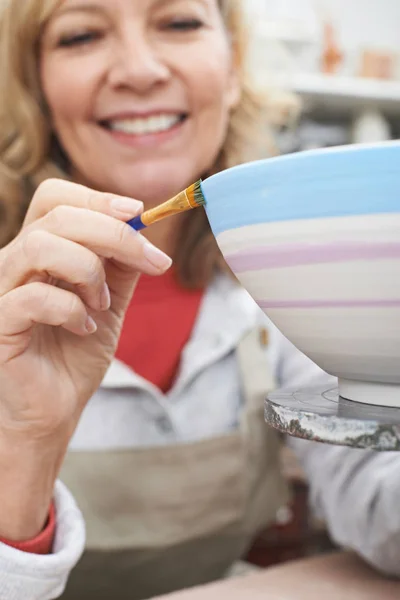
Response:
[202,142,400,235]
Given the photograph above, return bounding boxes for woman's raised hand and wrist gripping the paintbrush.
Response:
[0,180,171,539]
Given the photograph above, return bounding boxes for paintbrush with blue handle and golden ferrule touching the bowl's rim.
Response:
[128,180,206,231]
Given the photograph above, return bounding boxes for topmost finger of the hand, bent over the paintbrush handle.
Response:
[25,179,143,225]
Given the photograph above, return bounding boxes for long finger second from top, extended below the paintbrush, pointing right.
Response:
[22,205,172,275]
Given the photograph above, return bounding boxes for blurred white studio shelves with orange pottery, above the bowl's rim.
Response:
[246,0,400,151]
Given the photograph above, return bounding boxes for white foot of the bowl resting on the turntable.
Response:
[339,379,400,408]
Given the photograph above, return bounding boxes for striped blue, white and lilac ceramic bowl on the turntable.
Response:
[203,142,400,407]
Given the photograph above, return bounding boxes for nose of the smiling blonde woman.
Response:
[109,36,170,93]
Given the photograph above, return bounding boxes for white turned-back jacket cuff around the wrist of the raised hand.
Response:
[0,482,85,600]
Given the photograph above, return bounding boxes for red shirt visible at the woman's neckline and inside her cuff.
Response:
[0,268,203,554]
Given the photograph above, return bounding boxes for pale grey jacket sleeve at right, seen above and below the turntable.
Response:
[278,326,400,577]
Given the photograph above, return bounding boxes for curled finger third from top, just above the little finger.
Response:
[0,230,110,310]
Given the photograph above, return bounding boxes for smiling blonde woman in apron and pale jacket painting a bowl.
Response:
[0,0,400,600]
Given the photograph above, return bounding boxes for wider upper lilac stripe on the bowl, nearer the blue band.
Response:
[225,242,400,273]
